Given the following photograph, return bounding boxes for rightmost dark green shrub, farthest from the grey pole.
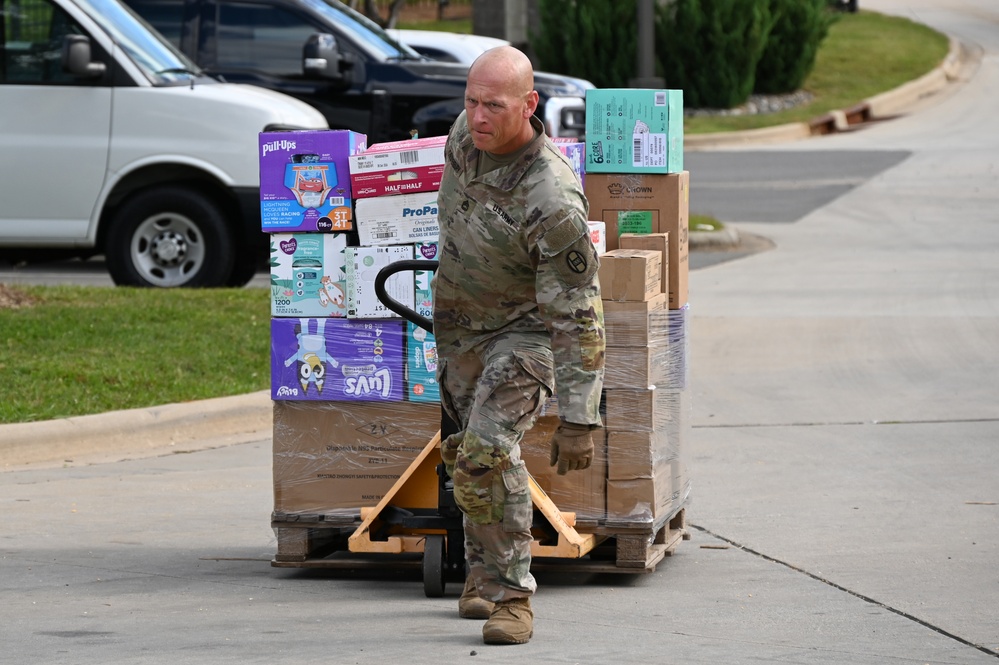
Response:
[754,0,835,94]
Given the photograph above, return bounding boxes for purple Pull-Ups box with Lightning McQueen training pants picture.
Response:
[259,130,367,233]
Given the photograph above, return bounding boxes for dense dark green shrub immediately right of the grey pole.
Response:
[656,0,773,108]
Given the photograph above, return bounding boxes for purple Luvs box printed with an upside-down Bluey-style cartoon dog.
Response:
[271,318,405,402]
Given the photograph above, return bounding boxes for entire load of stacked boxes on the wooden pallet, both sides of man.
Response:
[261,90,689,530]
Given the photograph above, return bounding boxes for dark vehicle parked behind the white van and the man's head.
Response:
[125,0,585,145]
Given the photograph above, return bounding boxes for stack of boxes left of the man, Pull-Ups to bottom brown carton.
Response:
[260,130,444,520]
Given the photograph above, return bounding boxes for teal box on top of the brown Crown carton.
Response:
[585,88,683,173]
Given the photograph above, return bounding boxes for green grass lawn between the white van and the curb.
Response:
[0,285,270,424]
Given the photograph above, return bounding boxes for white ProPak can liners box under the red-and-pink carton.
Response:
[354,191,441,246]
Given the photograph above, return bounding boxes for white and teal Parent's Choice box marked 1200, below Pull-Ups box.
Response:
[270,233,347,317]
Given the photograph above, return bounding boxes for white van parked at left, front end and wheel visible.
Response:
[0,0,328,287]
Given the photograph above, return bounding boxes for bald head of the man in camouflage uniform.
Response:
[465,46,538,155]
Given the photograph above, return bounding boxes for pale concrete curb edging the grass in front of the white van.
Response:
[0,390,272,471]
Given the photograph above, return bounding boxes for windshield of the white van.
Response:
[78,0,202,85]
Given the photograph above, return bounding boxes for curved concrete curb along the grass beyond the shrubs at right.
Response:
[683,38,965,150]
